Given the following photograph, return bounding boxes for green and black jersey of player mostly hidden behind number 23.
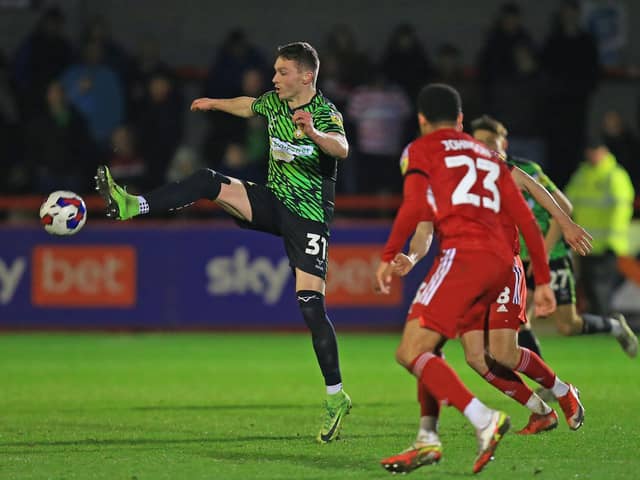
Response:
[507,155,569,261]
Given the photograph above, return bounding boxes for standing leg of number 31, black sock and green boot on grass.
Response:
[296,268,351,443]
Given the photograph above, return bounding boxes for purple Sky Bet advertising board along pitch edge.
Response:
[0,221,436,330]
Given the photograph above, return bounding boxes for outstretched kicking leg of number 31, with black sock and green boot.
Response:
[95,165,251,221]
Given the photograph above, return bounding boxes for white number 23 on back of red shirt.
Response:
[444,155,500,213]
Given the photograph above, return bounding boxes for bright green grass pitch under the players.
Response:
[0,334,640,480]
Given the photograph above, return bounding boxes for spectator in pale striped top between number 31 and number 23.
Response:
[346,71,411,193]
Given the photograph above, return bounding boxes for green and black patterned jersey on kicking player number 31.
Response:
[251,91,344,223]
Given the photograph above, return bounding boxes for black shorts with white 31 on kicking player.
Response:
[235,182,329,280]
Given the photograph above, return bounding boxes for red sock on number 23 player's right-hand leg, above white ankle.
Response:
[411,352,474,413]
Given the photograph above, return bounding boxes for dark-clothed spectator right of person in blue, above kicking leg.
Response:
[135,71,184,186]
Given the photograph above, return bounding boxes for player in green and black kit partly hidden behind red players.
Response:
[472,115,638,357]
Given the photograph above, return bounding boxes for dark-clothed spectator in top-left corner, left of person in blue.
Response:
[13,6,73,117]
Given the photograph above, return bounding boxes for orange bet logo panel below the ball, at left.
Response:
[31,245,137,307]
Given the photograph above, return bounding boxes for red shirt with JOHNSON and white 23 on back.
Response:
[401,128,528,257]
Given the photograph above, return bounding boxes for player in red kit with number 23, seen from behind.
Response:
[382,85,554,473]
